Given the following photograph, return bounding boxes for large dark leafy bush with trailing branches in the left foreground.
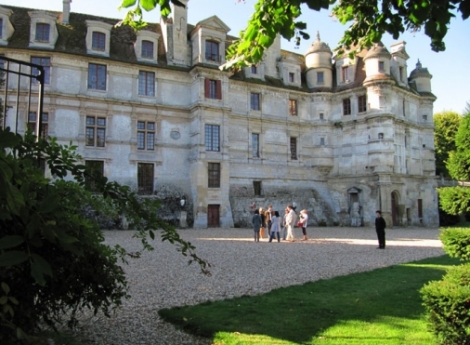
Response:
[0,128,207,342]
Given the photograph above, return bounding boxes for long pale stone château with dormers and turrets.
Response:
[0,1,439,228]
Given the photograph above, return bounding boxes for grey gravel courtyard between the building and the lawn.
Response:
[72,227,444,345]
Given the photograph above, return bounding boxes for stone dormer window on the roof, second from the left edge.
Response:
[28,11,59,49]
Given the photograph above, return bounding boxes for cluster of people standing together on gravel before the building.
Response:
[252,205,308,242]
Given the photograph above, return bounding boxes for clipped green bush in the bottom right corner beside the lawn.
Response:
[420,264,470,345]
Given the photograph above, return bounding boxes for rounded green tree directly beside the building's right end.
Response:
[434,111,462,176]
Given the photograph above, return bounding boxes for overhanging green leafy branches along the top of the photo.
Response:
[121,0,470,68]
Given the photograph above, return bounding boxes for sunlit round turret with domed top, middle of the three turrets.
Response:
[364,42,392,82]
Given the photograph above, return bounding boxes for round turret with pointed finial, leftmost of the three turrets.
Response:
[305,32,333,89]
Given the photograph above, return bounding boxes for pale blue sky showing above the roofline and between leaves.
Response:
[0,0,470,114]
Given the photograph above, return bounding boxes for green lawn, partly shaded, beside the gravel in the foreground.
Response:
[159,255,459,345]
